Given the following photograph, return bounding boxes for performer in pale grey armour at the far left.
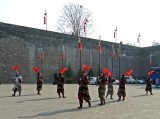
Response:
[12,72,22,96]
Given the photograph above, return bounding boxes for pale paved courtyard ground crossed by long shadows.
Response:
[0,84,160,119]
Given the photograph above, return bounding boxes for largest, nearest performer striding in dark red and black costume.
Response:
[78,71,91,108]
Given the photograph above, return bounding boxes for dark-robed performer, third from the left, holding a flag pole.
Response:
[56,73,66,98]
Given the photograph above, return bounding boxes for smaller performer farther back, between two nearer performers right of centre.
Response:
[106,76,115,99]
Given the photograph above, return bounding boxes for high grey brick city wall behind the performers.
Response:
[0,22,160,83]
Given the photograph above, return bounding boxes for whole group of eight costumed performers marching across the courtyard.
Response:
[12,71,153,109]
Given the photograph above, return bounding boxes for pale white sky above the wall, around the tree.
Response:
[0,0,160,47]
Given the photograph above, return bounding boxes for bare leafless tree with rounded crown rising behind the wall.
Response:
[57,3,92,36]
